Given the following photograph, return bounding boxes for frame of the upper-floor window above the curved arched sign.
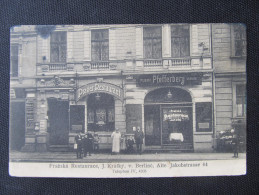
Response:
[91,29,110,62]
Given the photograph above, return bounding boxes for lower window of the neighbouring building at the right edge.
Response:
[236,85,246,117]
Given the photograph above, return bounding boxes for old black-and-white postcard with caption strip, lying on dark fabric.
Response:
[9,23,247,178]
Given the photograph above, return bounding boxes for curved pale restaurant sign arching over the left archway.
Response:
[76,83,123,101]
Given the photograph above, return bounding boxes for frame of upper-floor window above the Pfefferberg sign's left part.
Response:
[143,26,163,59]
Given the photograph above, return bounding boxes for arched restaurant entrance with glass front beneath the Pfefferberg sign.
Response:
[144,87,193,150]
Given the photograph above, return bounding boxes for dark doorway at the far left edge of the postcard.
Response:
[9,101,25,150]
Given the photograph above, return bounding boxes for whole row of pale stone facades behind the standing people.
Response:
[10,24,246,152]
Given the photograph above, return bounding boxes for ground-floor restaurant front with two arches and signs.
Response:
[11,73,222,152]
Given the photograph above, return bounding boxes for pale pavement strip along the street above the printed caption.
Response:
[9,151,246,163]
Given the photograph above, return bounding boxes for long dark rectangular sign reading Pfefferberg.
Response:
[137,73,202,87]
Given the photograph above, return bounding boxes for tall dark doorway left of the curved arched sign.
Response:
[48,98,69,145]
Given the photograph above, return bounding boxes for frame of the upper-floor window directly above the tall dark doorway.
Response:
[50,31,67,63]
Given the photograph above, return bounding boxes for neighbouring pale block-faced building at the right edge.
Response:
[212,24,246,149]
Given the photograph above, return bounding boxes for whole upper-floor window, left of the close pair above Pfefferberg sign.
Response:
[143,26,162,59]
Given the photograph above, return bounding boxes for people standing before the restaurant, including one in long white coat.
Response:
[74,127,144,158]
